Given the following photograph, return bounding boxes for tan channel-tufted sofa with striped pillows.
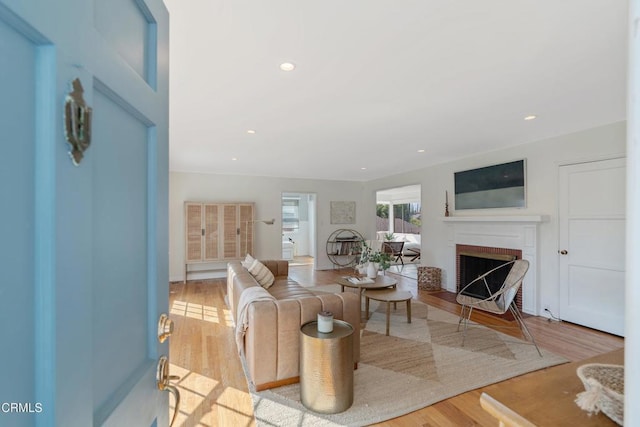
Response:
[227,260,360,390]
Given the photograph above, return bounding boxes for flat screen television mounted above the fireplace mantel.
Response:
[454,159,526,210]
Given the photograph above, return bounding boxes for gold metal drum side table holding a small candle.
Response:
[300,320,354,414]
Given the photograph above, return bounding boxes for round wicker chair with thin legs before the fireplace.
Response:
[456,259,542,357]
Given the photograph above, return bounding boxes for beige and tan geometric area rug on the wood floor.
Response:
[245,287,566,426]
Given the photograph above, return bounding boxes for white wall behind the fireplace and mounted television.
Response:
[364,122,626,314]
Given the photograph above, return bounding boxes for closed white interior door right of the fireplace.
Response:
[558,159,626,336]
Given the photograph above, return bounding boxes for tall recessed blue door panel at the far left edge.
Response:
[0,15,36,426]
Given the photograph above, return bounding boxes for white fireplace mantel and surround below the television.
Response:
[442,215,549,315]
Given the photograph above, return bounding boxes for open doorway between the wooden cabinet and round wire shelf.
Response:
[282,192,317,265]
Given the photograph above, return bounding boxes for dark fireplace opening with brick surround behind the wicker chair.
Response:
[456,245,522,311]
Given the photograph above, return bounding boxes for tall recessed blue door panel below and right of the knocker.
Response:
[92,91,153,425]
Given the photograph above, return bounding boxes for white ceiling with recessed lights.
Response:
[165,0,628,181]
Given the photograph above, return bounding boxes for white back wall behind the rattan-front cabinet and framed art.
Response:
[169,172,368,281]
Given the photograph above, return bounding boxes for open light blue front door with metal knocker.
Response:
[0,0,169,427]
